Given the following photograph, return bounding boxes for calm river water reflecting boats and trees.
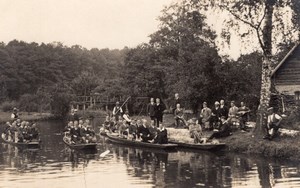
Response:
[0,121,300,188]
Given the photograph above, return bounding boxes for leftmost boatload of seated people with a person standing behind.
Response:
[2,108,39,143]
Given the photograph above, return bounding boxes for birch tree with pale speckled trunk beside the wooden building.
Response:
[190,0,300,134]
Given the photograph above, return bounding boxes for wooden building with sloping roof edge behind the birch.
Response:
[272,43,300,101]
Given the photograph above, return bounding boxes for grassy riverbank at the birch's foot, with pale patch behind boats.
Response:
[168,124,300,160]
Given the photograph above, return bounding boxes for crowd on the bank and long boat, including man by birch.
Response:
[103,93,282,143]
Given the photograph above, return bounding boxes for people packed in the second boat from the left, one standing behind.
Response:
[64,109,97,144]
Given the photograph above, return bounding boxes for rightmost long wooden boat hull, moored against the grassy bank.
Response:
[169,140,226,151]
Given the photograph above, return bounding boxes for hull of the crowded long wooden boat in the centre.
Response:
[107,133,177,149]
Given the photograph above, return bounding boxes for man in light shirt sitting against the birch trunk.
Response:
[264,107,282,140]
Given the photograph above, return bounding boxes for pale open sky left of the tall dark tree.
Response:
[0,0,172,49]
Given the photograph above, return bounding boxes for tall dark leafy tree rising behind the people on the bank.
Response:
[150,1,221,108]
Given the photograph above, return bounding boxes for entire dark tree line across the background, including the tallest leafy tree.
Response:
[0,0,299,119]
